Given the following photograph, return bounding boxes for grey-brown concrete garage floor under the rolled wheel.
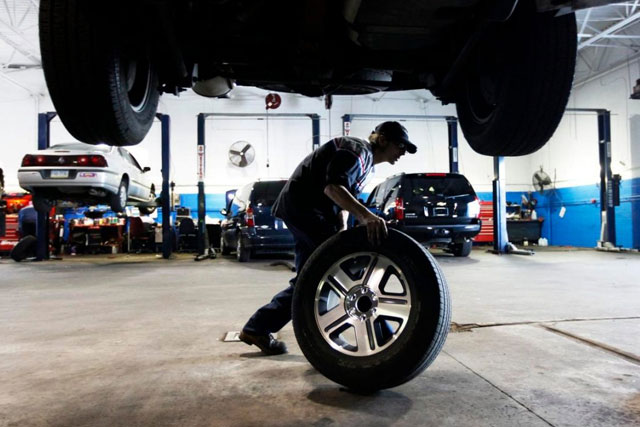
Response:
[0,248,640,427]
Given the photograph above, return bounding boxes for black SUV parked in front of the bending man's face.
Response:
[366,173,480,256]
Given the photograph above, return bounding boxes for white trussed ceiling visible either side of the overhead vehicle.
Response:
[0,0,640,94]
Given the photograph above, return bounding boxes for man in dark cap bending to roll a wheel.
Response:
[239,122,417,355]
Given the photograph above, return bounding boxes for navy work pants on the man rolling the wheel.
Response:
[243,219,337,335]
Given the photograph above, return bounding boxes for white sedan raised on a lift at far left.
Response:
[18,142,156,214]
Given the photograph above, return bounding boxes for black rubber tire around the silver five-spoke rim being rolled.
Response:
[293,228,448,390]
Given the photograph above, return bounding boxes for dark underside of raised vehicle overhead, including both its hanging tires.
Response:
[39,0,613,156]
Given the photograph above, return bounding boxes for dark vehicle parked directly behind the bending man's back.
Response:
[220,179,295,262]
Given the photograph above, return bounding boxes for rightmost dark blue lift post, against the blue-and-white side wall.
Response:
[598,110,616,247]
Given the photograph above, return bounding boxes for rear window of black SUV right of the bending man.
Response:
[403,175,476,202]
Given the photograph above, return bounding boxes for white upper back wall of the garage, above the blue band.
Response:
[0,71,576,197]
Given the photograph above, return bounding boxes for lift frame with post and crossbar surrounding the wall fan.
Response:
[196,113,320,259]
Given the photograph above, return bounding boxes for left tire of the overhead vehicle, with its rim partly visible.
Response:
[39,0,160,146]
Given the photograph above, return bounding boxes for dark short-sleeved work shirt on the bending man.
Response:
[272,136,373,225]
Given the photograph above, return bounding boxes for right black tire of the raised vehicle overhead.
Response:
[456,2,577,156]
